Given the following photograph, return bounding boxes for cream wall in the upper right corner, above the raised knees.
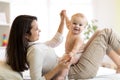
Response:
[93,0,120,31]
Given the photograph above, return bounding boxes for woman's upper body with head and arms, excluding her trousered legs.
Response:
[7,11,69,80]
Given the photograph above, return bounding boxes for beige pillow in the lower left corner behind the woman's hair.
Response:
[0,61,23,80]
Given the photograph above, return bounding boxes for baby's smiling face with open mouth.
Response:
[71,17,86,35]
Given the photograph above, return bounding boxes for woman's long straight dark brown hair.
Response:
[6,15,37,72]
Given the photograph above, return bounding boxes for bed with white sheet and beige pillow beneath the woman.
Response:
[0,48,120,80]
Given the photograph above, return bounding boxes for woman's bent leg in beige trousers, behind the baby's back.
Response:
[69,29,120,79]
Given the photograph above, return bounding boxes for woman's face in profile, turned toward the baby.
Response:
[27,20,40,42]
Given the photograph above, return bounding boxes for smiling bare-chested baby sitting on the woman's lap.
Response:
[56,11,88,80]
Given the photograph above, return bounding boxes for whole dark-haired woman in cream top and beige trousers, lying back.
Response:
[7,10,120,80]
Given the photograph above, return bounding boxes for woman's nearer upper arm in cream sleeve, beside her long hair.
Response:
[27,44,45,80]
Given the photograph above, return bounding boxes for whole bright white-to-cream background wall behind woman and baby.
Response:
[11,0,120,41]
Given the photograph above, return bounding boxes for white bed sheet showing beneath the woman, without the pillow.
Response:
[23,67,120,80]
